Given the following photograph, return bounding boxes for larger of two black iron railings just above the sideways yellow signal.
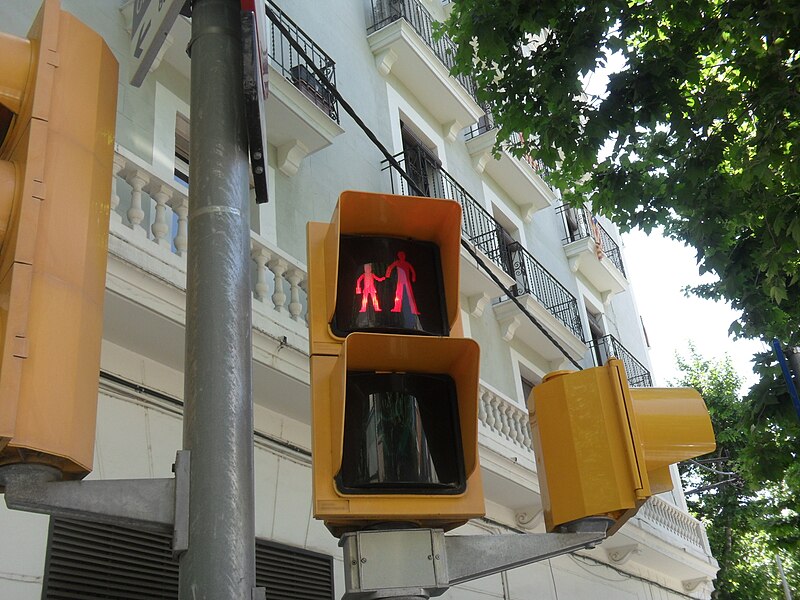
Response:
[508,242,583,340]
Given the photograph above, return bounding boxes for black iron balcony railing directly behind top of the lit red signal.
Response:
[381,148,512,275]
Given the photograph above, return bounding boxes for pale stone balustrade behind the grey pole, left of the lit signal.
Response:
[110,150,307,328]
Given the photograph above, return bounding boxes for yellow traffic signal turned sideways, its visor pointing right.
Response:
[528,358,715,535]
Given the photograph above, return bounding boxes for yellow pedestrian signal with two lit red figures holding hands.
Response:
[308,192,484,536]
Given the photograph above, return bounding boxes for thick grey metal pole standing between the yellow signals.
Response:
[180,0,255,600]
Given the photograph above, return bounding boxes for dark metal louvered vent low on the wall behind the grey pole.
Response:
[42,518,334,600]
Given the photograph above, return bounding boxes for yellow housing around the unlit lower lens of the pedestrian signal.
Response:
[311,333,478,535]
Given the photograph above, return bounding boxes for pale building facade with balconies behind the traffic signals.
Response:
[0,0,717,600]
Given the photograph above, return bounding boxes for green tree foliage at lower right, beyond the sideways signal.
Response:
[676,347,800,600]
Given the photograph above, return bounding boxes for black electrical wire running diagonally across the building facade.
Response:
[265,4,583,371]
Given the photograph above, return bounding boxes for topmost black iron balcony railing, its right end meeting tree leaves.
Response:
[367,0,478,102]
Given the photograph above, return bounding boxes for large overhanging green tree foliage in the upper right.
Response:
[446,0,800,345]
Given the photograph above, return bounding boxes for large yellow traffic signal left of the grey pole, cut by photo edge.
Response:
[0,0,118,486]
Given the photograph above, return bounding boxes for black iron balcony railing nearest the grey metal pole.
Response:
[267,0,339,123]
